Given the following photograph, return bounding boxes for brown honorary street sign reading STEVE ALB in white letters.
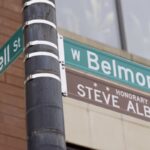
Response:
[67,69,150,121]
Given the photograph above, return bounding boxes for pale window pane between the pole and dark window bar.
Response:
[56,0,121,48]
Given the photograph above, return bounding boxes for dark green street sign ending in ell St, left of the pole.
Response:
[0,27,23,73]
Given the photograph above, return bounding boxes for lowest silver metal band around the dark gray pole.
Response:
[24,73,61,84]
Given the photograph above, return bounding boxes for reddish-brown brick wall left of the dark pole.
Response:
[0,0,26,150]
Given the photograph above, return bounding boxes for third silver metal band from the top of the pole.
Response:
[25,40,58,50]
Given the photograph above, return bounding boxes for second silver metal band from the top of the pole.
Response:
[23,19,56,29]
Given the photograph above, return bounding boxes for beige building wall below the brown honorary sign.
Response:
[64,98,150,150]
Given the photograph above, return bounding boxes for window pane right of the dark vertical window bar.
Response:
[121,0,150,59]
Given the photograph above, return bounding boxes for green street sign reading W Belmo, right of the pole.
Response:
[64,38,150,93]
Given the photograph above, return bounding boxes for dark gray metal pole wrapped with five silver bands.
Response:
[24,0,66,150]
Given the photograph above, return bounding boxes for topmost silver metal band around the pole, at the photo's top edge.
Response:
[24,0,56,8]
